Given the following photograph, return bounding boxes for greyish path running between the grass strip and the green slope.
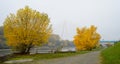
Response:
[23,51,100,64]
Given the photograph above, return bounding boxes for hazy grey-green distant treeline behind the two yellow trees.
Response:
[0,26,74,49]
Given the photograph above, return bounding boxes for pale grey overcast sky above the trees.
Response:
[0,0,120,40]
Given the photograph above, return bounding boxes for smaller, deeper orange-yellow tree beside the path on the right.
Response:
[74,25,101,50]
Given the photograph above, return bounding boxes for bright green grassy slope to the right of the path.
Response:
[101,42,120,64]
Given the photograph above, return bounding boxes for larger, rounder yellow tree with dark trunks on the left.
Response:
[4,6,52,53]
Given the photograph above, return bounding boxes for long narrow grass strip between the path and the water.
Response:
[0,48,100,64]
